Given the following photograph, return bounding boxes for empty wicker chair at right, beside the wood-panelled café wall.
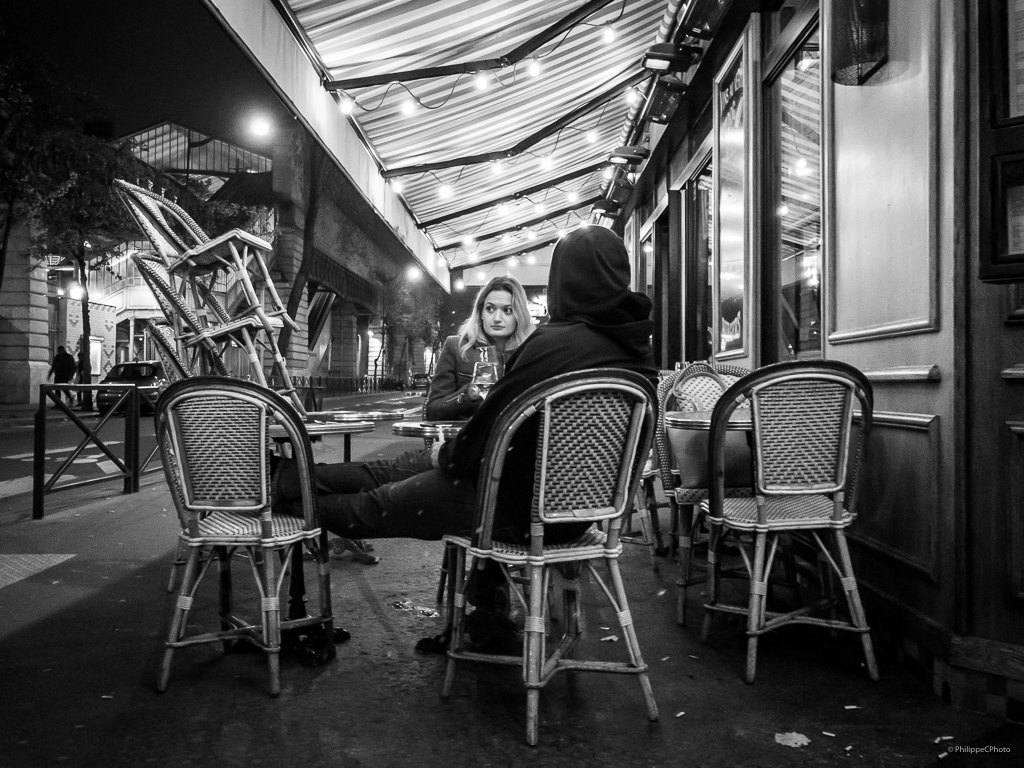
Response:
[701,360,879,683]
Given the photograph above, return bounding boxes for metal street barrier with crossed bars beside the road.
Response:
[32,384,157,520]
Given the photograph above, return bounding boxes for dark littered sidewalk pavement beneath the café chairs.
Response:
[0,425,1024,768]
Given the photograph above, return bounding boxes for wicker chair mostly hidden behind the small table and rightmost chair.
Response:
[654,362,754,625]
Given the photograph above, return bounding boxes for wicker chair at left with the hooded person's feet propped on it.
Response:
[156,377,334,696]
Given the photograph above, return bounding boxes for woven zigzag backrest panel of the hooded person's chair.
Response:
[534,390,632,520]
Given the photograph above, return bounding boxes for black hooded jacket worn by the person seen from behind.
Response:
[439,226,657,543]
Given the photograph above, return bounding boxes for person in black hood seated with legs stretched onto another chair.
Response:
[274,226,657,544]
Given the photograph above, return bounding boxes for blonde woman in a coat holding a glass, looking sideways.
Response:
[424,276,534,421]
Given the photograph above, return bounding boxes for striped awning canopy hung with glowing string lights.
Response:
[279,0,684,268]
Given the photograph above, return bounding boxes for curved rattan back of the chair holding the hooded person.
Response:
[474,369,654,552]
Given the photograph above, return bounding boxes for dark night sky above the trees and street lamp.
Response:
[0,0,292,151]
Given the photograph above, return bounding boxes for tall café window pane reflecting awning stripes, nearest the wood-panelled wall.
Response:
[764,30,822,360]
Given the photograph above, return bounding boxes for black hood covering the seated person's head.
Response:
[548,226,654,346]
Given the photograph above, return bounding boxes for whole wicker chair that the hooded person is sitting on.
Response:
[441,369,657,744]
